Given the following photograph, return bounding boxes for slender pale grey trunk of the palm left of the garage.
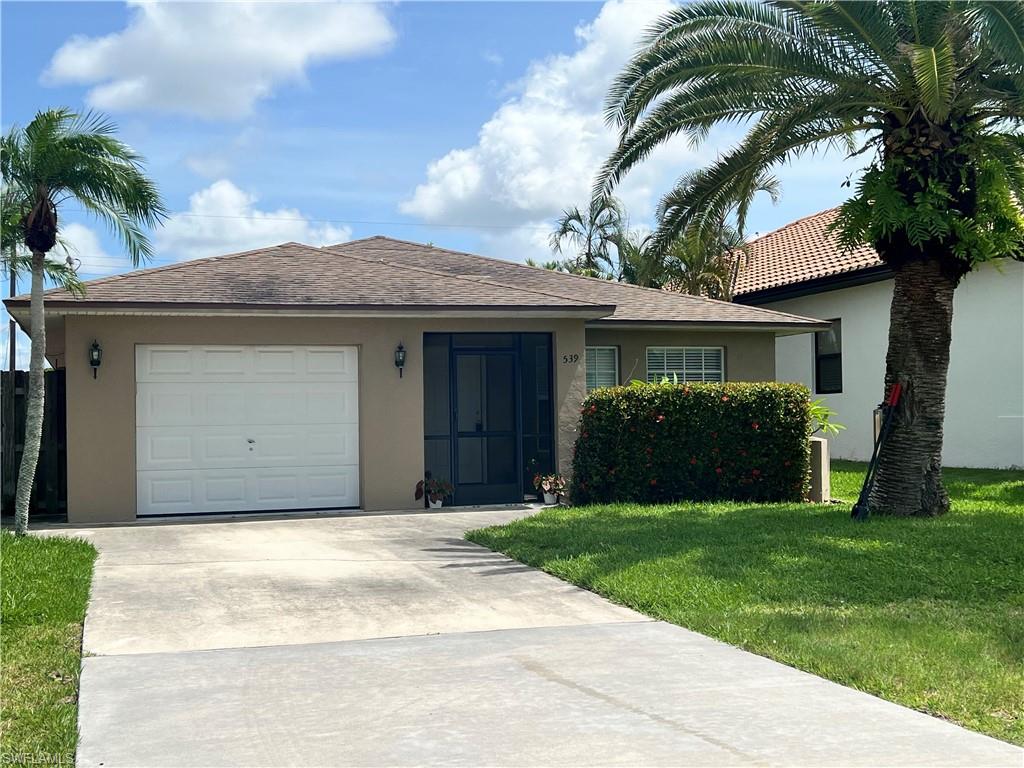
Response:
[14,251,46,535]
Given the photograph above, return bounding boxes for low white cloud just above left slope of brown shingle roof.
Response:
[155,179,352,261]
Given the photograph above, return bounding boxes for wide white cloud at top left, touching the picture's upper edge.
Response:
[43,1,395,118]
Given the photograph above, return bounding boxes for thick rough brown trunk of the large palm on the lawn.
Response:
[868,259,956,516]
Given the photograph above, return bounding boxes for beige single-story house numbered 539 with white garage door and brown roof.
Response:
[5,238,826,522]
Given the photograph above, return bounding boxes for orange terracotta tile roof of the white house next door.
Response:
[734,208,883,296]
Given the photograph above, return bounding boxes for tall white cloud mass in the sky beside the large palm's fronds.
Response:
[400,0,696,240]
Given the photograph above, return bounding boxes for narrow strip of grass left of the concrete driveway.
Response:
[0,530,96,765]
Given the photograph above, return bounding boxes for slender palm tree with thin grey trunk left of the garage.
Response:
[0,109,167,534]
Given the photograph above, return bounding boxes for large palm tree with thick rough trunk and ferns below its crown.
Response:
[595,0,1024,515]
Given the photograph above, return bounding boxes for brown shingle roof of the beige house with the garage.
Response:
[5,237,817,327]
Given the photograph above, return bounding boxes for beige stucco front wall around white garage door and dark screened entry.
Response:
[64,315,586,523]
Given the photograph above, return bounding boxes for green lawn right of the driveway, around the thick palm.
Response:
[467,462,1024,744]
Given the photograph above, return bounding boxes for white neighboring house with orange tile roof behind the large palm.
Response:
[735,209,1024,467]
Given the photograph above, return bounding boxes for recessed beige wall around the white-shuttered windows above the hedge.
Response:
[587,328,775,384]
